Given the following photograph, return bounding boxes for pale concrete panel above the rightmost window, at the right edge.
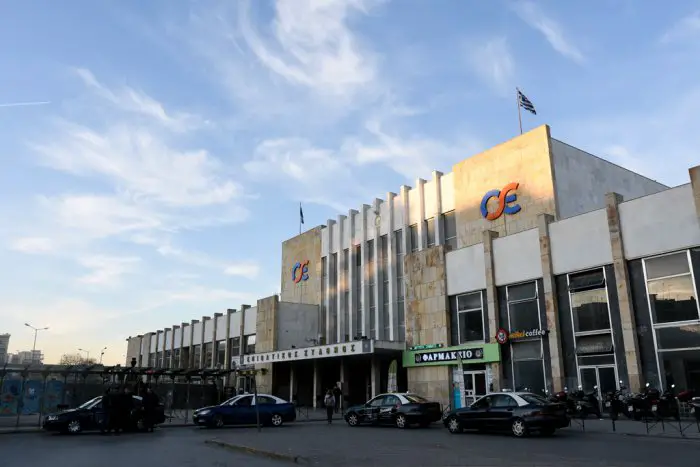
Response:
[619,184,700,259]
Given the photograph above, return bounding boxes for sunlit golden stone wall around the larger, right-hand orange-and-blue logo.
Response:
[453,125,556,247]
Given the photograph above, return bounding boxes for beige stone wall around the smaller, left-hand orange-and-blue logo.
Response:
[281,227,324,305]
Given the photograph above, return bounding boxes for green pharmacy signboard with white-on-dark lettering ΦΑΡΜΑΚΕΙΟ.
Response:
[403,344,501,367]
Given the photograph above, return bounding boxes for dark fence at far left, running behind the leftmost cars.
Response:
[0,366,241,430]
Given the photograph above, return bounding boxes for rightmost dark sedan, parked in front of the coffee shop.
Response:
[443,392,570,437]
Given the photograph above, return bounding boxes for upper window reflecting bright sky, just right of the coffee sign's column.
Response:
[569,269,610,333]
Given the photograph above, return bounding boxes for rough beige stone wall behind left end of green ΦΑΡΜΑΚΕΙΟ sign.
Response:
[405,246,450,405]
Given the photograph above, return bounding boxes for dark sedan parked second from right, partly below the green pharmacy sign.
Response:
[344,393,442,428]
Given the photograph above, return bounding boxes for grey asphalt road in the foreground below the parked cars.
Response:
[0,423,700,467]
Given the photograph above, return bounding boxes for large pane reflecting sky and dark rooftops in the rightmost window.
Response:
[647,274,698,323]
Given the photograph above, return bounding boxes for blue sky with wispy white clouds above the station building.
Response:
[0,0,700,362]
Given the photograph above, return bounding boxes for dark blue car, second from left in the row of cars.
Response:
[192,394,297,428]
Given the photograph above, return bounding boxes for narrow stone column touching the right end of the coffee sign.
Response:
[537,214,564,392]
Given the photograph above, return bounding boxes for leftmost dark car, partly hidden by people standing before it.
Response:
[43,396,165,434]
